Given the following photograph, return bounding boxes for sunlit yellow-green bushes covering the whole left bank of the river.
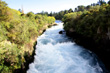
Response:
[0,0,55,73]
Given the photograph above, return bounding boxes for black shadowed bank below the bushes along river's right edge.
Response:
[66,31,110,71]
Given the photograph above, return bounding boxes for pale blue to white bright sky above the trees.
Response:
[2,0,109,13]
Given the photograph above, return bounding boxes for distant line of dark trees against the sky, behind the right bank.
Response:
[38,0,109,20]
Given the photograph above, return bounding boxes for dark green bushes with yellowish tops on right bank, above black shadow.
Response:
[62,4,110,39]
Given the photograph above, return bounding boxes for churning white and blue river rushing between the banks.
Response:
[27,21,106,73]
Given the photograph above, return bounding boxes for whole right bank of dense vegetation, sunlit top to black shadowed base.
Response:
[62,1,110,71]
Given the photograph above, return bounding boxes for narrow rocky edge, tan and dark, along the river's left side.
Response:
[14,23,57,73]
